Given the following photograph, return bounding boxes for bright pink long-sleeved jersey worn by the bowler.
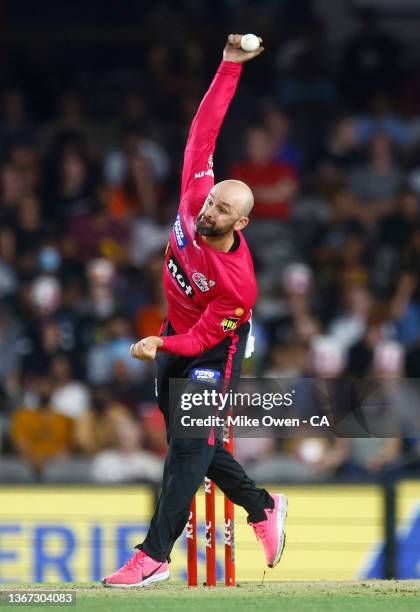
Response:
[160,61,257,356]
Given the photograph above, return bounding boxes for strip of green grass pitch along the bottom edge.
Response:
[0,580,420,612]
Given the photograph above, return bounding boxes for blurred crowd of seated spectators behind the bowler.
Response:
[0,4,420,483]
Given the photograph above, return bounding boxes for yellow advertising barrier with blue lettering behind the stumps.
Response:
[4,482,420,583]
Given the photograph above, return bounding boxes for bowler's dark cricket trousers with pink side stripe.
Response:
[136,322,273,561]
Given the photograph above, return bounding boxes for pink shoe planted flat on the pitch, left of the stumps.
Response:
[102,550,169,589]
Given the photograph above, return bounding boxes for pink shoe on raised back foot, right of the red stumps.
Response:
[249,495,287,567]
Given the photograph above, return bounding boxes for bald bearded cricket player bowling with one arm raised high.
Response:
[102,34,287,588]
